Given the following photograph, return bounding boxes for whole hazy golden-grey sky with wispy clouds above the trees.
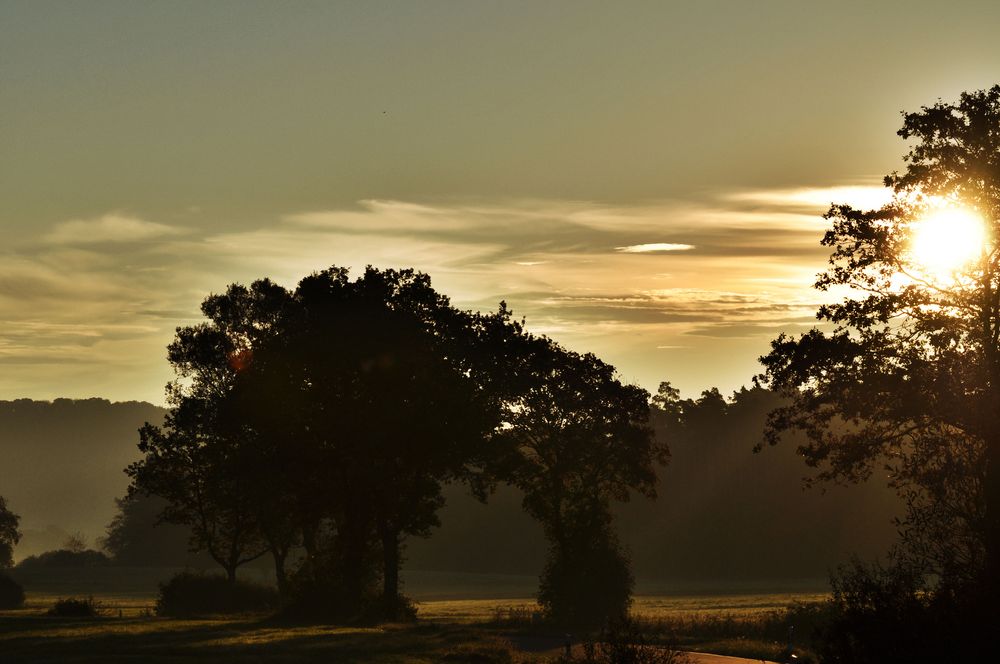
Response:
[0,0,1000,403]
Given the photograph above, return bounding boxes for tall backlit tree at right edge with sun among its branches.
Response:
[760,86,1000,612]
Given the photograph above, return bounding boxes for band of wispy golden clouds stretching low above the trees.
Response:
[0,188,872,400]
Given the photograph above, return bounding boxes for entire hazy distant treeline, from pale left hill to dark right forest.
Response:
[0,389,902,583]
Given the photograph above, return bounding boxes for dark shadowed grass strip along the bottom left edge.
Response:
[0,614,533,664]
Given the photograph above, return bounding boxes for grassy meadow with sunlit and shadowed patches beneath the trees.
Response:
[0,584,824,664]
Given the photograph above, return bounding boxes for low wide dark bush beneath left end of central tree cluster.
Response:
[156,572,278,617]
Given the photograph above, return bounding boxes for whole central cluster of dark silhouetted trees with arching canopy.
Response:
[129,267,666,619]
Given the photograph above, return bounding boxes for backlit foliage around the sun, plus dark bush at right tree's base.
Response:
[760,86,1000,662]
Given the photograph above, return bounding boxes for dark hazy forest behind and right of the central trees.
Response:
[407,389,903,584]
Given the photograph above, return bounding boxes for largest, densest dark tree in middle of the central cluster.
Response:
[238,268,506,616]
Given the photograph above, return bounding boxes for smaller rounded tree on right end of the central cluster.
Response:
[505,338,668,625]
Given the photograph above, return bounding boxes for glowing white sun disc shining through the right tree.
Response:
[910,207,987,279]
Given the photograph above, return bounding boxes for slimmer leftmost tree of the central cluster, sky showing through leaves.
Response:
[127,280,288,581]
